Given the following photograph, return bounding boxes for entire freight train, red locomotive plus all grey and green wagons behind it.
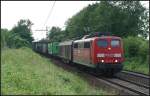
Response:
[33,32,124,75]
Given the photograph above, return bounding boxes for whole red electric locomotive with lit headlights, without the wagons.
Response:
[73,33,124,75]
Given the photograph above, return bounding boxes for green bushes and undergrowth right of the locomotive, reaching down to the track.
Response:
[123,36,149,74]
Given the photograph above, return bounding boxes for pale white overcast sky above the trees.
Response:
[1,1,149,41]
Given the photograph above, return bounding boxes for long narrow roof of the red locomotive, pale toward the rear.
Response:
[74,36,121,43]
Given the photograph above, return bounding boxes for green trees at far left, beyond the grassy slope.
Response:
[1,19,34,48]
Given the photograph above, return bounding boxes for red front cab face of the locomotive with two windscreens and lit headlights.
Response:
[95,36,124,74]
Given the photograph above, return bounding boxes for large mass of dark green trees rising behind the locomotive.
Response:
[66,1,149,38]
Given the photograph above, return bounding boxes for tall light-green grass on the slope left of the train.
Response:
[1,48,111,95]
